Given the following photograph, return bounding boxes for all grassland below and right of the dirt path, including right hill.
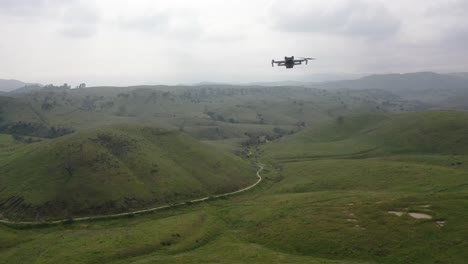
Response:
[0,112,468,263]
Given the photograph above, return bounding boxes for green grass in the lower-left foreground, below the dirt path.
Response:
[0,205,370,263]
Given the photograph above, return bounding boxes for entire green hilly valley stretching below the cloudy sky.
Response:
[0,72,468,264]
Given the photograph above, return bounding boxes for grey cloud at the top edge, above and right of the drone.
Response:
[273,0,400,38]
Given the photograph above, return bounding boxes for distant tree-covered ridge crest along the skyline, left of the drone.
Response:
[24,84,327,111]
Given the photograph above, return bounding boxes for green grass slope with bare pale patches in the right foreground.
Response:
[232,159,468,263]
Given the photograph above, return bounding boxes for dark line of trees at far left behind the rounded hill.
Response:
[0,121,74,138]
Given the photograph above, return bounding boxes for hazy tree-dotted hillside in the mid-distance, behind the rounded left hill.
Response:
[0,86,424,140]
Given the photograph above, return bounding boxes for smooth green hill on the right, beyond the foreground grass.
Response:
[264,111,468,160]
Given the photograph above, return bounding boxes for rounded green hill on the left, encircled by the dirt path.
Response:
[0,126,256,220]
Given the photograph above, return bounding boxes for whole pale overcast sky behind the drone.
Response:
[0,0,468,85]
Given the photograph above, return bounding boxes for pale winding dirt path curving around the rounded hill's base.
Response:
[0,163,265,225]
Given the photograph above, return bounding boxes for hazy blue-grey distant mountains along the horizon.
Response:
[0,72,468,104]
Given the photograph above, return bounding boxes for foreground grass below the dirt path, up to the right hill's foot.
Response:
[0,154,468,263]
